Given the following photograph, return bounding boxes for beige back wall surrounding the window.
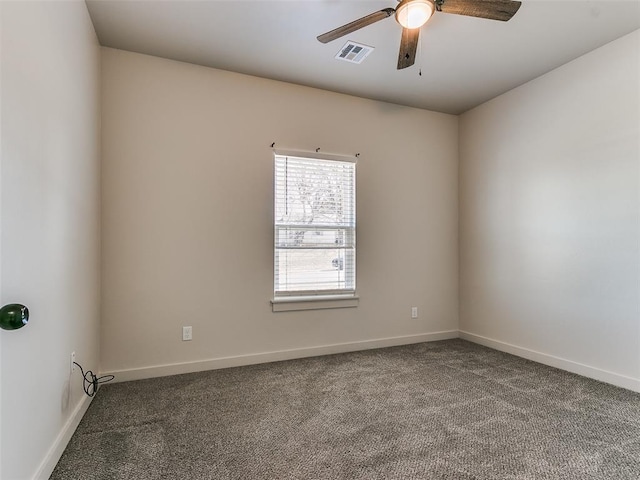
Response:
[101,48,458,379]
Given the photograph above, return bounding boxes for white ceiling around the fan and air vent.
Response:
[86,0,640,114]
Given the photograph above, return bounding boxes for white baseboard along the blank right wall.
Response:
[459,330,640,393]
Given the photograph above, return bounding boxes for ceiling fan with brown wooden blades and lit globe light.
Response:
[317,0,521,70]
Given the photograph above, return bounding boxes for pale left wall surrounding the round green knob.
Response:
[0,1,100,480]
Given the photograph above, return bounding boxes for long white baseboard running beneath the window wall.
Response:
[101,330,458,382]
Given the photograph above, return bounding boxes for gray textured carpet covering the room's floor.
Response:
[51,340,640,480]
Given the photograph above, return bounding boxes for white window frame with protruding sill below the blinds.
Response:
[271,150,359,312]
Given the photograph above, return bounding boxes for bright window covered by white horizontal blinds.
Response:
[274,154,356,306]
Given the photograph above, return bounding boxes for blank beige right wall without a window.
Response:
[460,31,640,389]
